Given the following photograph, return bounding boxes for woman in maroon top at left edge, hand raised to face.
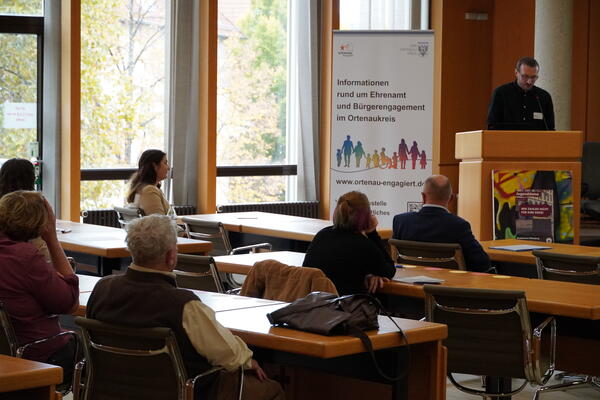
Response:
[0,190,79,381]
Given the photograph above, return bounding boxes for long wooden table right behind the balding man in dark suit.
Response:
[381,267,600,376]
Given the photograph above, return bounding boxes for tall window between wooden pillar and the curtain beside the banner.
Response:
[217,0,295,204]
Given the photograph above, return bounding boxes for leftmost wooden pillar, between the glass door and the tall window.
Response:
[60,0,81,221]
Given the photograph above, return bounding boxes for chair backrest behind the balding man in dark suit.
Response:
[388,239,466,271]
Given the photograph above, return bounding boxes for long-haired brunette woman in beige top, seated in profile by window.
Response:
[127,149,170,215]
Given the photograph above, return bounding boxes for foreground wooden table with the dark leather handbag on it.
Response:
[76,276,447,400]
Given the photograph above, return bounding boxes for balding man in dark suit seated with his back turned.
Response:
[393,175,491,271]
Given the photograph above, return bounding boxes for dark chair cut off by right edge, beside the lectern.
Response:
[581,142,600,220]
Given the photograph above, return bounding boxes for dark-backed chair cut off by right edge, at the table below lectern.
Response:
[532,250,600,392]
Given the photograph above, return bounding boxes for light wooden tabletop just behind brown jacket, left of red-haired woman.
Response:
[215,251,306,275]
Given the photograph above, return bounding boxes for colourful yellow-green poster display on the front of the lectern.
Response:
[492,170,574,243]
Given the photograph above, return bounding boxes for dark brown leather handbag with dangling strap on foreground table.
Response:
[267,292,409,381]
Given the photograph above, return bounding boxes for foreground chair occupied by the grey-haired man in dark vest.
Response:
[73,317,243,400]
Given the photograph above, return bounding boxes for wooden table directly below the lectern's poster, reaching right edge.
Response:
[481,239,600,265]
